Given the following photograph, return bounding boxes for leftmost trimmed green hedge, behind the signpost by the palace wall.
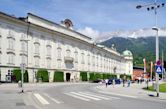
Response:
[13,68,29,82]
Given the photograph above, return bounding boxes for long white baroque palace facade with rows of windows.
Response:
[0,12,133,82]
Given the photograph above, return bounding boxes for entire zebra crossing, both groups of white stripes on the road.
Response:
[33,91,120,105]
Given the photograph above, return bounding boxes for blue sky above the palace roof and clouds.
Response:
[0,0,166,37]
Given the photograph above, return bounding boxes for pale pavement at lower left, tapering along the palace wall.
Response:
[0,83,67,109]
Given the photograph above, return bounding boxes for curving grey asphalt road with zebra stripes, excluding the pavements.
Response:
[25,83,166,109]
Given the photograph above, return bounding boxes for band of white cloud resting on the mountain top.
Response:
[77,27,166,42]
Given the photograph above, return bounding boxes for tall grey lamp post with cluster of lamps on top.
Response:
[136,0,165,97]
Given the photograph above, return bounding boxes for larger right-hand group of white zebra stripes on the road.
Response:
[64,92,120,101]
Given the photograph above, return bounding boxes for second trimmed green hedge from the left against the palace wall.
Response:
[37,69,49,82]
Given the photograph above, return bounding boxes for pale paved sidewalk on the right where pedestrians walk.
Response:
[96,83,166,101]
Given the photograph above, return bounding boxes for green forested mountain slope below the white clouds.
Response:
[100,36,166,65]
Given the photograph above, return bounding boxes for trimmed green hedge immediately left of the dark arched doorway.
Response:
[54,71,64,82]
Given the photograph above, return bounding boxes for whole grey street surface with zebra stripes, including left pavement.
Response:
[0,83,166,109]
